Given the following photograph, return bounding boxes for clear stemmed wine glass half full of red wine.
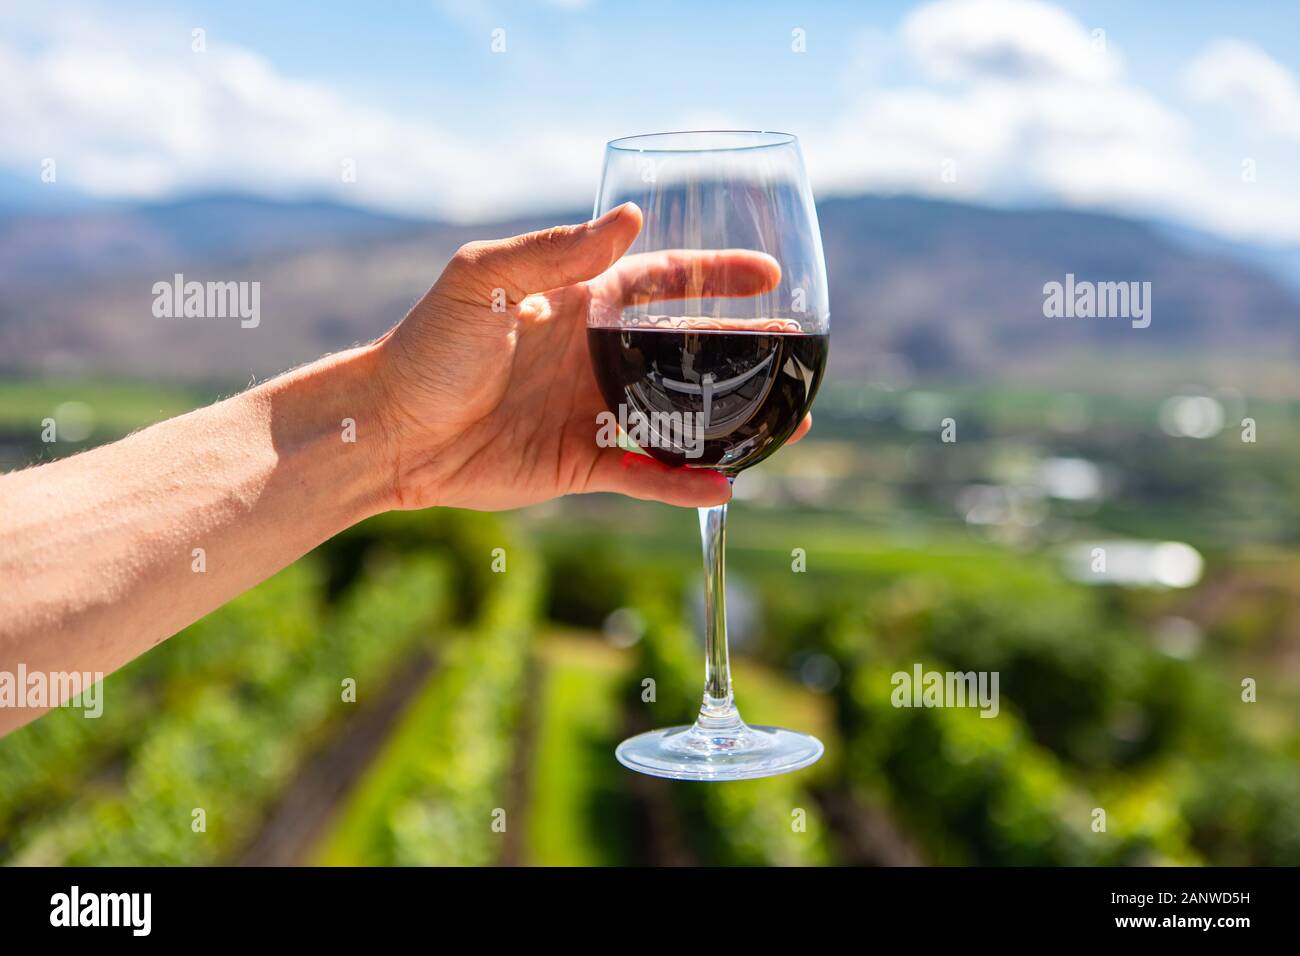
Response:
[588,130,831,780]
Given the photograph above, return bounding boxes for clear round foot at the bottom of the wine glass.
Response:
[614,718,824,780]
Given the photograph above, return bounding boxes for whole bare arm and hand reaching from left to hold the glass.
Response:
[0,206,806,702]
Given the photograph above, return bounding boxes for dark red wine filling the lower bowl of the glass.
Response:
[586,328,829,475]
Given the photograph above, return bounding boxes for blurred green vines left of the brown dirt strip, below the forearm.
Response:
[0,548,447,865]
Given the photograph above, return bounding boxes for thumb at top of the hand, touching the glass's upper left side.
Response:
[447,203,641,302]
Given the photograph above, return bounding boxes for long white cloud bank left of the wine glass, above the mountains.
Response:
[0,14,602,219]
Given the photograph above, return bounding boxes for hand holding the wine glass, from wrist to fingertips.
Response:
[377,203,810,510]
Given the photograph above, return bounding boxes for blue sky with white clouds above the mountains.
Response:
[0,0,1300,242]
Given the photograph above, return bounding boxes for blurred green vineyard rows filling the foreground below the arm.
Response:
[0,382,1300,866]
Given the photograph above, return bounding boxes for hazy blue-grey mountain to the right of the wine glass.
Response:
[820,196,1300,376]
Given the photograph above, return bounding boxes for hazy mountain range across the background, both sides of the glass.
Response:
[0,196,1300,388]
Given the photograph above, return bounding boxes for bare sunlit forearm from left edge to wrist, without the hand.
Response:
[0,347,391,732]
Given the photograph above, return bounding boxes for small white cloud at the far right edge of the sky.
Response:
[1183,39,1300,140]
